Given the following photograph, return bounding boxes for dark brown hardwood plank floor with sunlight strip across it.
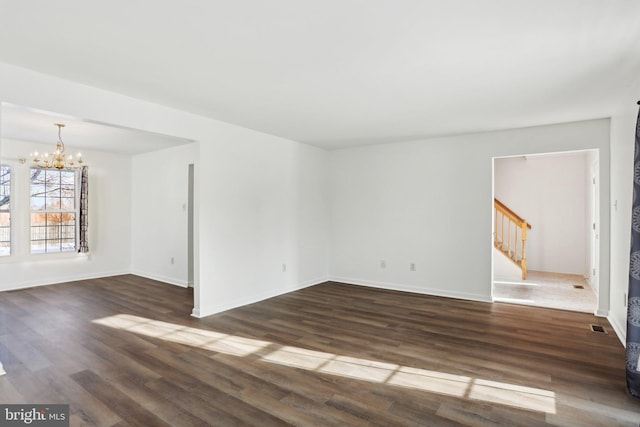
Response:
[0,275,640,427]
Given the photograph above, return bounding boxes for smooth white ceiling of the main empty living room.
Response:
[0,0,640,148]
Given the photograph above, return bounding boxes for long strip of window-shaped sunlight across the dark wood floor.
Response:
[93,314,556,414]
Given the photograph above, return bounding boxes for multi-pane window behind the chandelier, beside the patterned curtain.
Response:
[30,168,78,253]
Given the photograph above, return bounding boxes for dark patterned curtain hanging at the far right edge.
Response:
[627,102,640,399]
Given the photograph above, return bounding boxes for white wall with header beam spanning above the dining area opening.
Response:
[0,63,328,316]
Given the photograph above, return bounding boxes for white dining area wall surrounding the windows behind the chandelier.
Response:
[0,138,131,291]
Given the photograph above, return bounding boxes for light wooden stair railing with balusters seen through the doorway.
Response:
[493,199,531,280]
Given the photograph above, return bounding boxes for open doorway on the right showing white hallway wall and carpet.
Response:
[492,150,599,313]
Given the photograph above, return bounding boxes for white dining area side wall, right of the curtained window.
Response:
[131,143,198,286]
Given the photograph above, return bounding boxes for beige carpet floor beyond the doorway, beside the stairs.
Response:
[493,271,597,313]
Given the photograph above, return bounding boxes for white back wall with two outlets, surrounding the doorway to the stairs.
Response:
[329,119,609,314]
